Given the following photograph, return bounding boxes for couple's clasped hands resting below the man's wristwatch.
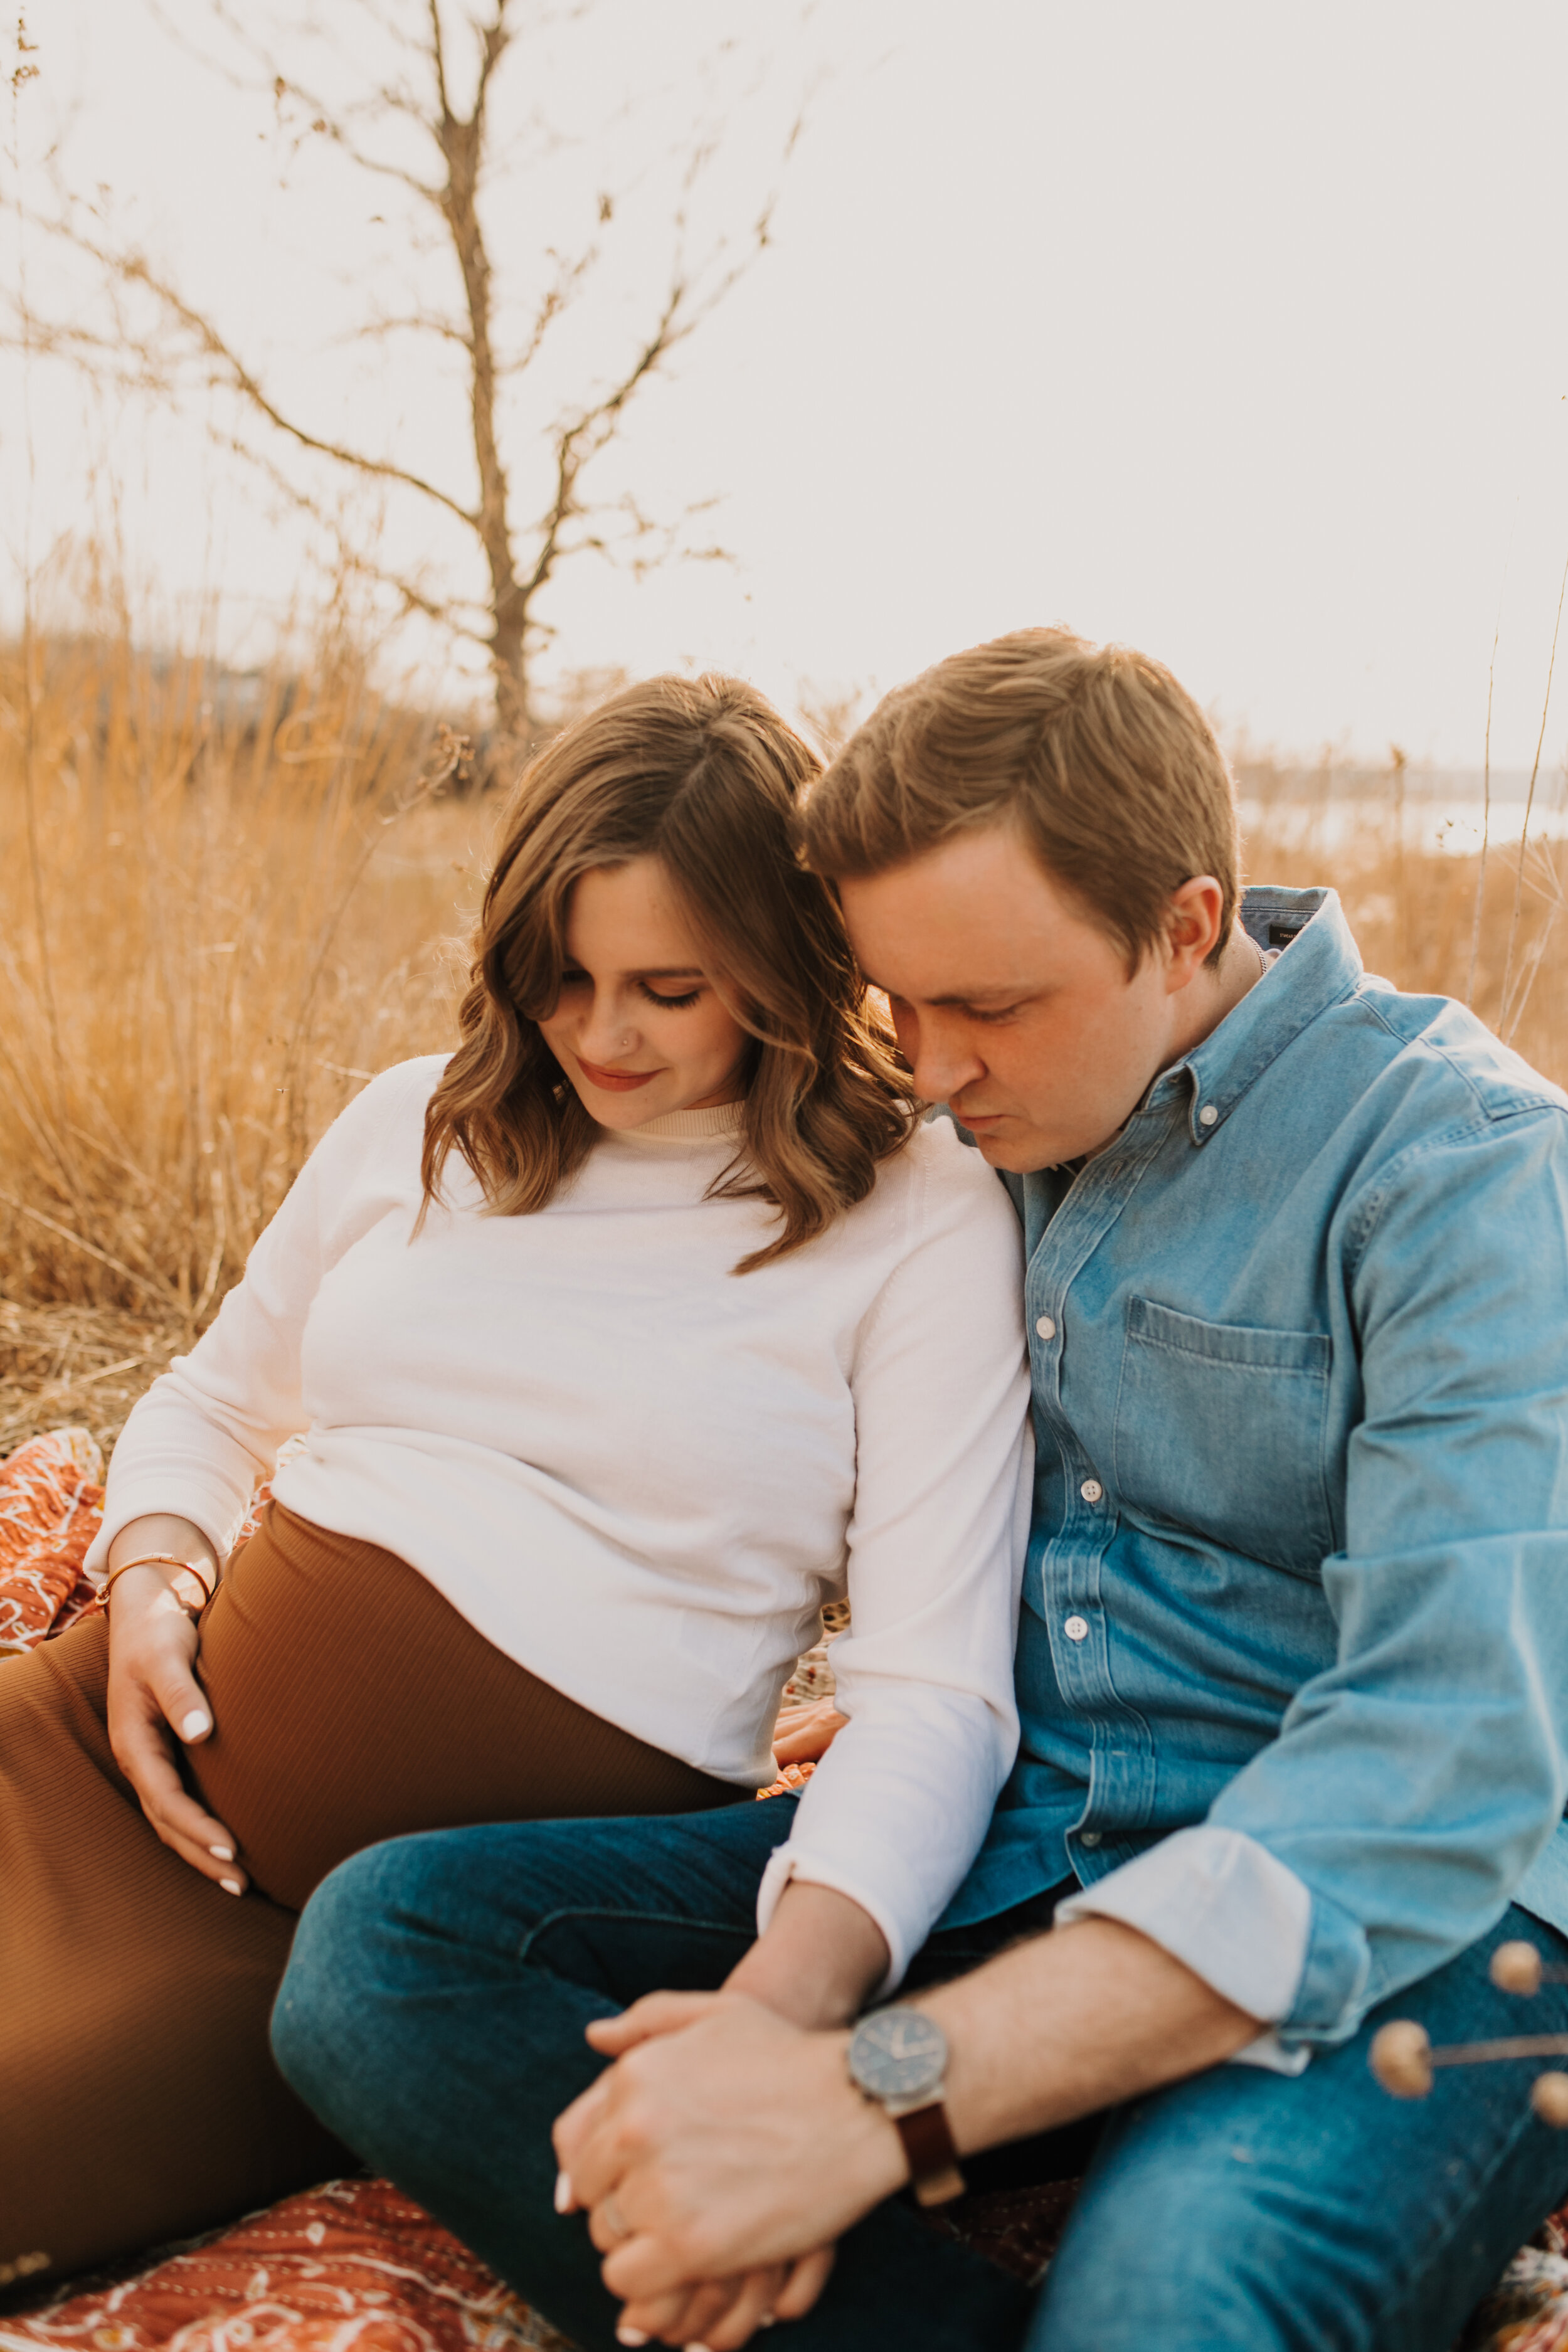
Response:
[555,1992,908,2352]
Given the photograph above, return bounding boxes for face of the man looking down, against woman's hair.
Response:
[839,824,1197,1173]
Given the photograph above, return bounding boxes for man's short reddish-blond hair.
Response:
[804,628,1241,969]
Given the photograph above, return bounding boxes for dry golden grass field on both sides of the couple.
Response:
[0,630,1568,1454]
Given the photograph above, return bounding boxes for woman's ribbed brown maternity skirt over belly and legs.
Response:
[0,1505,738,2277]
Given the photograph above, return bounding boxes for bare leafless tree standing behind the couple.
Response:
[31,0,802,743]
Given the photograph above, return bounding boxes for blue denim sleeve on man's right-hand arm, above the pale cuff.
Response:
[1201,1101,1568,2047]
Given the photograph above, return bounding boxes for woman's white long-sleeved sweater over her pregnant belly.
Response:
[92,1056,1030,1978]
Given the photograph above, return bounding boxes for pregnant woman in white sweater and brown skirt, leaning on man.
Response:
[0,677,1027,2274]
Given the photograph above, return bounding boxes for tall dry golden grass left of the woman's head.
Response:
[0,640,489,1324]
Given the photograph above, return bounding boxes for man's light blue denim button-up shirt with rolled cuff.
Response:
[943,889,1568,2058]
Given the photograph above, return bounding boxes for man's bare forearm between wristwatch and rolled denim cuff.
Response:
[917,1919,1263,2152]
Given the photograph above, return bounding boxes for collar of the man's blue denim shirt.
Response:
[1140,884,1364,1145]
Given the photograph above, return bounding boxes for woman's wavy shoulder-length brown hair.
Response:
[421,677,914,1273]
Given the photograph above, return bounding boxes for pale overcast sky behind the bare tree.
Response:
[0,0,1568,765]
